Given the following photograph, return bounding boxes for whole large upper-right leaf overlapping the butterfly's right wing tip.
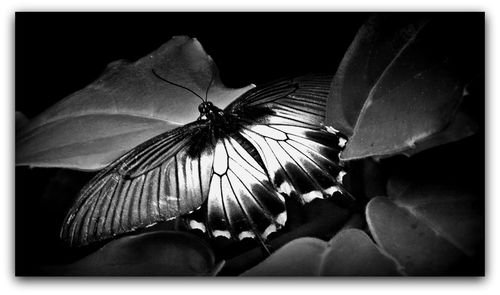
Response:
[326,14,478,160]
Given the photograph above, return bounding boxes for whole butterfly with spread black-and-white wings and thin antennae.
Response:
[61,70,352,246]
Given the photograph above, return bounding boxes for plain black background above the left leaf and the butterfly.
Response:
[16,12,368,118]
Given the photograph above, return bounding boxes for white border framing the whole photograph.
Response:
[0,0,500,295]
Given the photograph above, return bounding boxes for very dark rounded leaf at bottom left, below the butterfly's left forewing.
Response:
[45,231,220,276]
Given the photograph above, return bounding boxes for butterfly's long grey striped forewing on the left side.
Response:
[61,121,213,246]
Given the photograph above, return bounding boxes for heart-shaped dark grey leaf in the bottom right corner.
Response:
[366,191,481,275]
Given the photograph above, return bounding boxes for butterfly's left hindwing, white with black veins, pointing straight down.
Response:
[207,137,286,240]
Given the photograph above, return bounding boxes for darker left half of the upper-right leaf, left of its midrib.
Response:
[326,14,425,136]
